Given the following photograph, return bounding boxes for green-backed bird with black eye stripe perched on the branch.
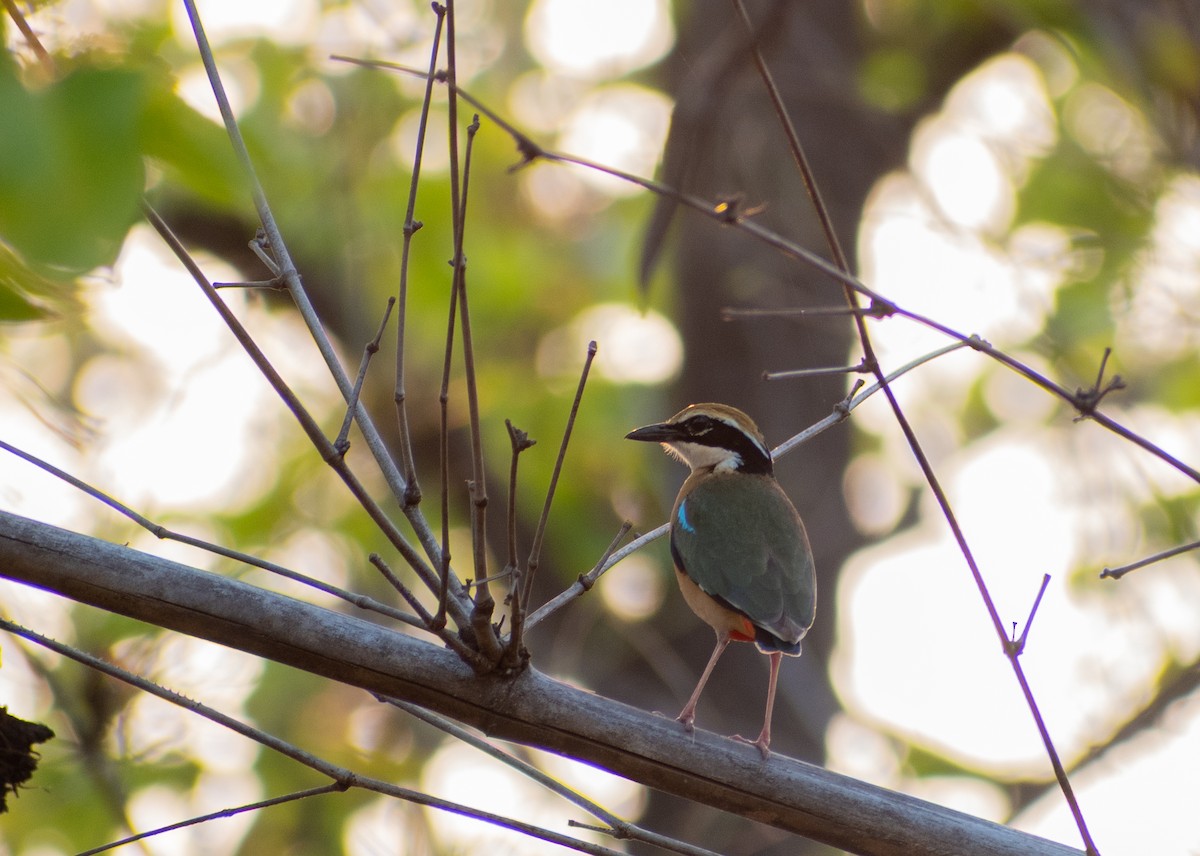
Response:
[625,403,816,759]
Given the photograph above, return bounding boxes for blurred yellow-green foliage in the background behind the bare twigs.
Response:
[0,0,1200,855]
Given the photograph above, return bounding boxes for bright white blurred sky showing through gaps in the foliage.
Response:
[0,0,1200,856]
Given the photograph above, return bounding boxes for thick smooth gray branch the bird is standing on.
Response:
[0,513,1081,856]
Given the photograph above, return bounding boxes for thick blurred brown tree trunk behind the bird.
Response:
[624,0,1012,854]
